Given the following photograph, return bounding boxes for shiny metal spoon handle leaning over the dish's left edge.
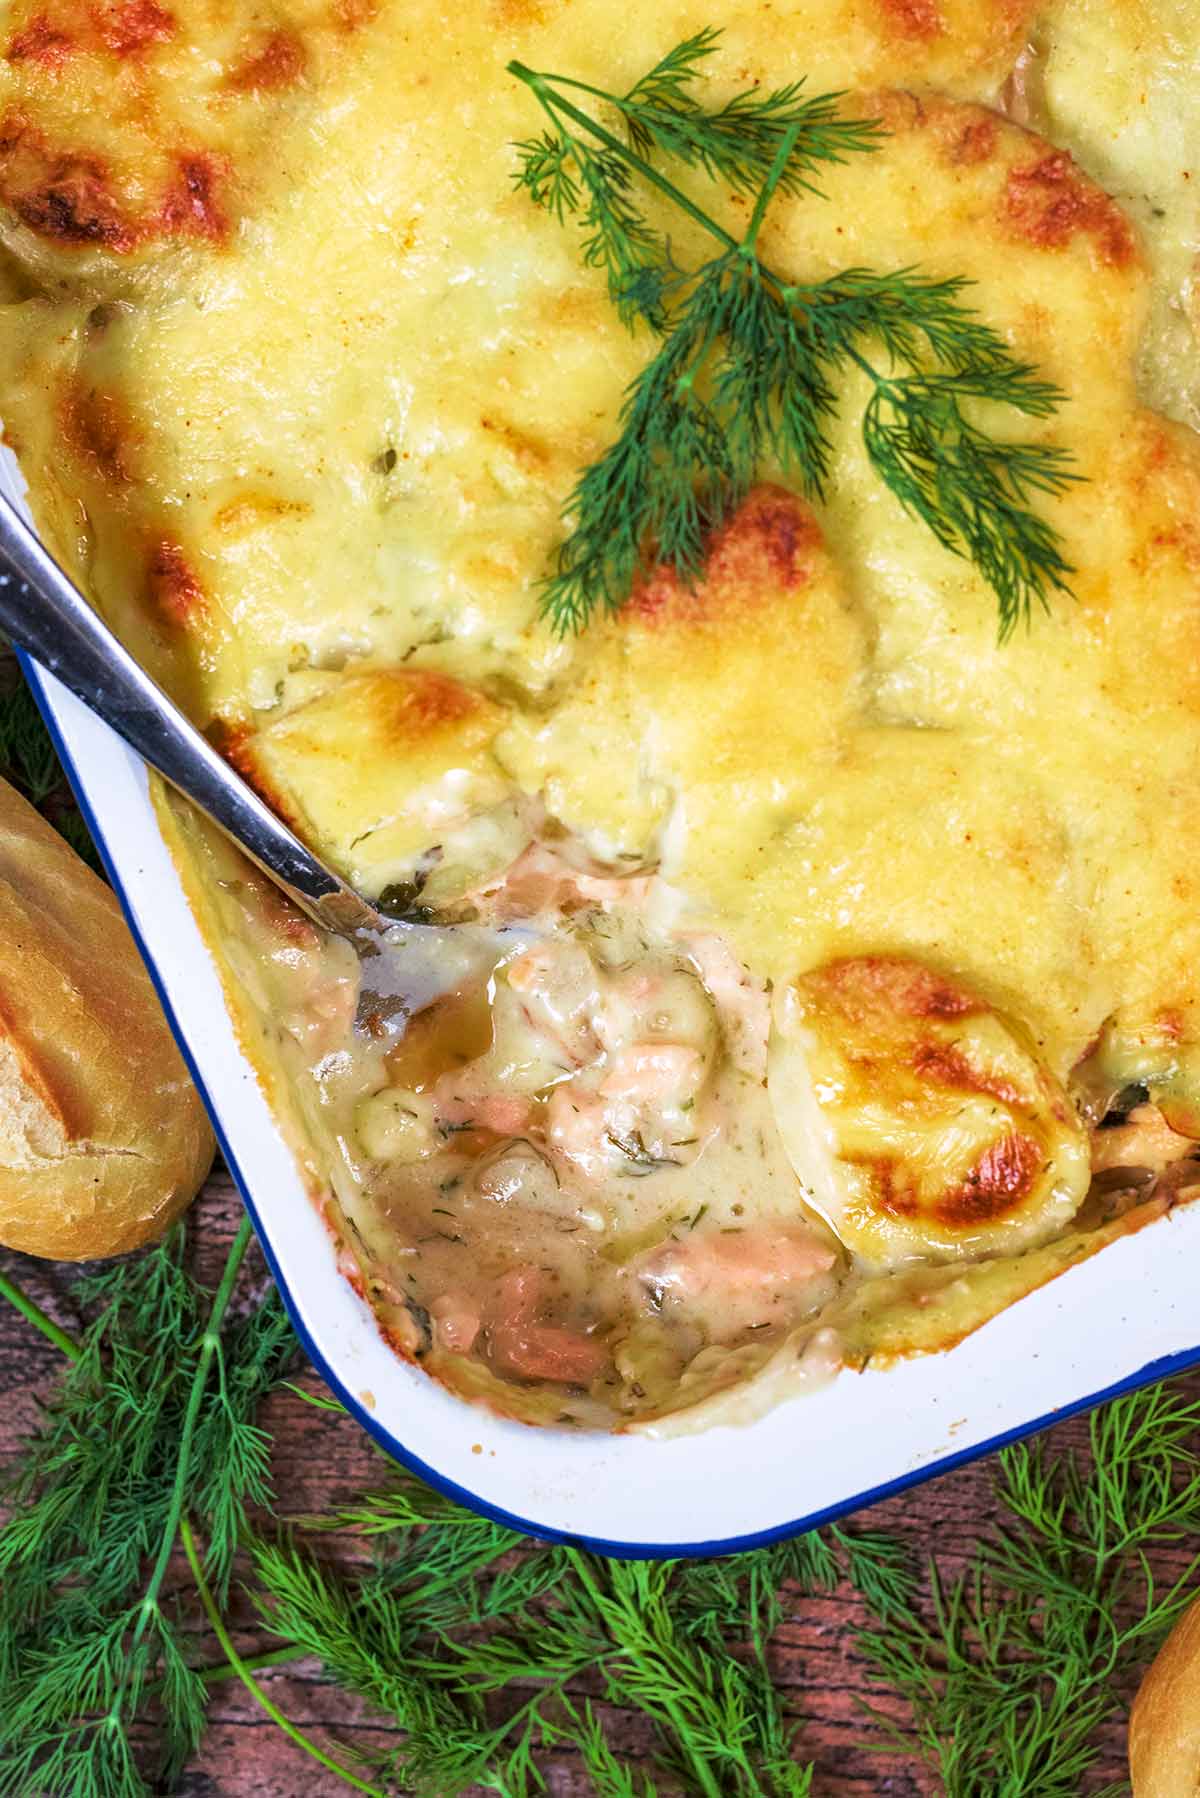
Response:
[0,494,383,935]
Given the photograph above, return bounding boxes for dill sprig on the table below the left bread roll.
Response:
[0,1226,293,1798]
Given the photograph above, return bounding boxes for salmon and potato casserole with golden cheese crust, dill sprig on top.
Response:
[0,0,1200,1429]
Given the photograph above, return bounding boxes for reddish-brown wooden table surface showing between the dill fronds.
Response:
[0,1174,1200,1798]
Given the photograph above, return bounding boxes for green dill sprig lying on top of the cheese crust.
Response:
[507,31,1079,640]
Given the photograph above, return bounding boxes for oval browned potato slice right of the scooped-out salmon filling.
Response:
[768,955,1090,1266]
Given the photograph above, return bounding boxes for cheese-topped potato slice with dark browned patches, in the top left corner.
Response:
[0,0,369,273]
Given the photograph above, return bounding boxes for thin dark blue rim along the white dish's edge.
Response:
[16,651,1200,1561]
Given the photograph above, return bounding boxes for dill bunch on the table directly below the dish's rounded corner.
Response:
[254,1474,910,1798]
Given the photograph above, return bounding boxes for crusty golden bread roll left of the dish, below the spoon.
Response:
[0,780,212,1260]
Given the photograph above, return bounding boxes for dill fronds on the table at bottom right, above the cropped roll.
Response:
[860,1386,1200,1798]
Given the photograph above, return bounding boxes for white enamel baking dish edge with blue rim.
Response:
[9,438,1200,1555]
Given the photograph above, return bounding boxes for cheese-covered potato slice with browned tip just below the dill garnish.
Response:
[497,487,867,855]
